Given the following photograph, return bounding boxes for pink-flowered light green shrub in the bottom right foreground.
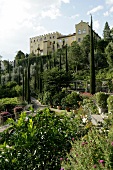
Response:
[62,123,113,170]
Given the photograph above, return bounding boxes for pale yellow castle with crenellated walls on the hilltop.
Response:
[30,20,101,55]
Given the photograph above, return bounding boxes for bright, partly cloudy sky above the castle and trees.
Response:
[0,0,113,61]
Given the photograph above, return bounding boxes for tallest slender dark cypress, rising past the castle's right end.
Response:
[90,15,95,94]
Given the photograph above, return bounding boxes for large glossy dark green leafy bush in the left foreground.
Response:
[0,109,83,170]
